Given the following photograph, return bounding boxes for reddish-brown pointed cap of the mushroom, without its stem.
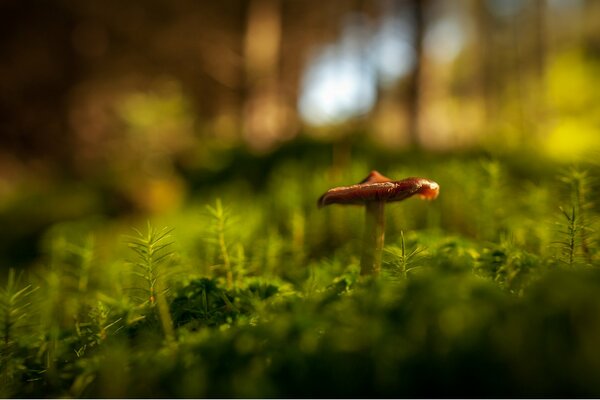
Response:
[318,171,440,208]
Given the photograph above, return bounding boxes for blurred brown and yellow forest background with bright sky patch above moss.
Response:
[0,0,600,268]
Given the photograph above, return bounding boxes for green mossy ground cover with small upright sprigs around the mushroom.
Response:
[0,148,600,397]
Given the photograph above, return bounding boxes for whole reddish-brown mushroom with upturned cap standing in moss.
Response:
[318,171,440,275]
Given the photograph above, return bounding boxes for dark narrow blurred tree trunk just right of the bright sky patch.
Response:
[407,0,428,146]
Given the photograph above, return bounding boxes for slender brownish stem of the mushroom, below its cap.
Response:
[360,201,385,275]
